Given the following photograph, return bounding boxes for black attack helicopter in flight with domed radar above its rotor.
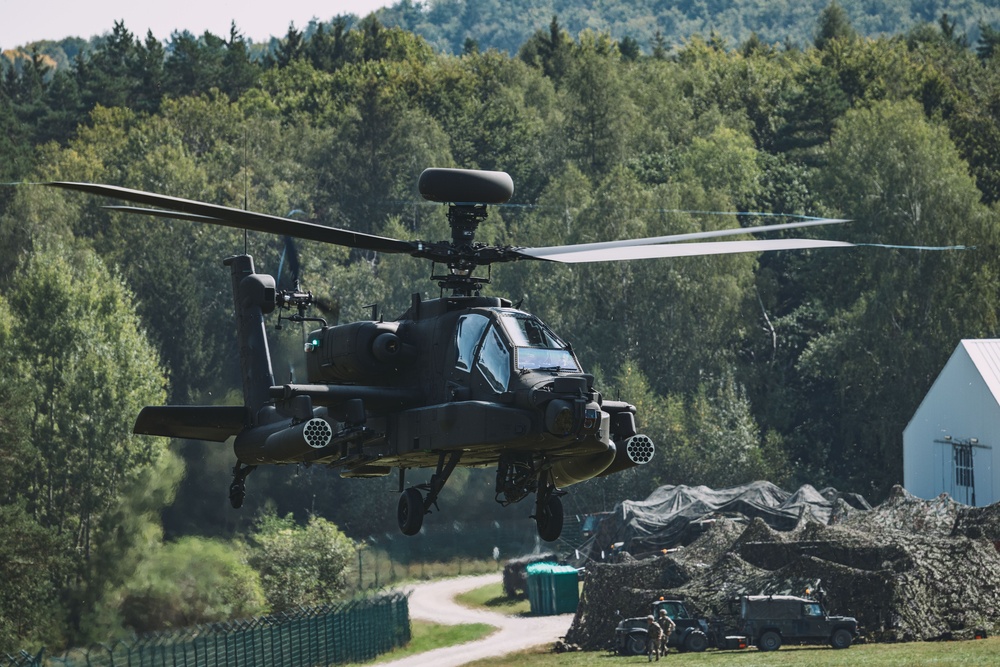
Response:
[47,168,852,542]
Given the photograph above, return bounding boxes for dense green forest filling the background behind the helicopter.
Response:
[0,4,1000,650]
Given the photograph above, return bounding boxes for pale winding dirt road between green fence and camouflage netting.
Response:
[380,573,573,667]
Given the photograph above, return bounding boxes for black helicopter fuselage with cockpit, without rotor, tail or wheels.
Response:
[250,290,634,487]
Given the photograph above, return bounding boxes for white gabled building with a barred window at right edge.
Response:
[903,339,1000,507]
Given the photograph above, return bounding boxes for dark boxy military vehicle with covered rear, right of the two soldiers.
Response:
[739,595,858,651]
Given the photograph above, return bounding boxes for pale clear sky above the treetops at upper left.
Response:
[0,0,394,50]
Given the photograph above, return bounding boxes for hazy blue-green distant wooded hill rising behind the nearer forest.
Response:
[378,0,1000,57]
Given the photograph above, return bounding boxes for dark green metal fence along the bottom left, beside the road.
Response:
[5,593,410,667]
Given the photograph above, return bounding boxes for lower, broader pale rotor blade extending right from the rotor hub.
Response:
[516,239,854,264]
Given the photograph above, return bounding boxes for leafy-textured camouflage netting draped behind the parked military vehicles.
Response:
[566,487,1000,650]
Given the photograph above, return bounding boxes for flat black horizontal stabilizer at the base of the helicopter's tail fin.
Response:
[132,405,247,442]
